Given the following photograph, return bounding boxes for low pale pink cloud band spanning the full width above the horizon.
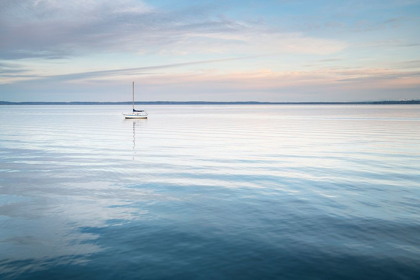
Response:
[0,66,420,101]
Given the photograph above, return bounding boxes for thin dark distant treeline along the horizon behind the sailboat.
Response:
[0,100,420,105]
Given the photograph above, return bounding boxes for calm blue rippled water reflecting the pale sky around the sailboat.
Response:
[0,105,420,279]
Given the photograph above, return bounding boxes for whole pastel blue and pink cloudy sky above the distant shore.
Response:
[0,0,420,102]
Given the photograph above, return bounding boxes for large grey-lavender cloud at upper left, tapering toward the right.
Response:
[0,0,345,59]
